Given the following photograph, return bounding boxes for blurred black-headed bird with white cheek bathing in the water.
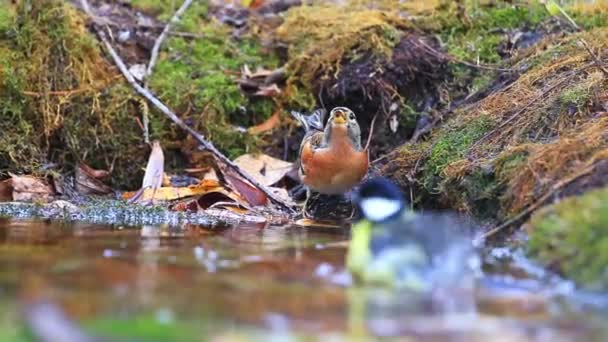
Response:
[346,177,478,291]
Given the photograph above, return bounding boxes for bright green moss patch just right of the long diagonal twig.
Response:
[132,0,278,157]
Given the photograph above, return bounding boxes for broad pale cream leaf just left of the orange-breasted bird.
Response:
[234,154,293,186]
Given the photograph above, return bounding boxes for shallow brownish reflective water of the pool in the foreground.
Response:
[0,219,608,341]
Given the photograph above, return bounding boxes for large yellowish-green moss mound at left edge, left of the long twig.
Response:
[0,0,157,186]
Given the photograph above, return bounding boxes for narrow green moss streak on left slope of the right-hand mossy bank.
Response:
[423,116,493,191]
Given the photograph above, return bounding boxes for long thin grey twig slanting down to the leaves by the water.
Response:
[81,0,295,213]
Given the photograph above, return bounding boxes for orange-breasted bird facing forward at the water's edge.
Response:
[292,107,371,218]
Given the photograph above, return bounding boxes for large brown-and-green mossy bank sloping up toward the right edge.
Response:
[388,20,608,220]
